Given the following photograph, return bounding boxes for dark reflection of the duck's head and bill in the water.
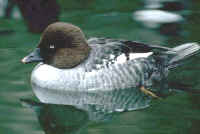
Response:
[21,100,89,134]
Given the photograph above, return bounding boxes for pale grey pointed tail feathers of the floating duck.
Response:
[166,43,200,69]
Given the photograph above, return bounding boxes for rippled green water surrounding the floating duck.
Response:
[0,0,200,134]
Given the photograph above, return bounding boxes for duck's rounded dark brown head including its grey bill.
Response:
[22,22,90,68]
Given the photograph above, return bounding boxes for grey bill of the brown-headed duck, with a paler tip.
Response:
[21,48,43,64]
